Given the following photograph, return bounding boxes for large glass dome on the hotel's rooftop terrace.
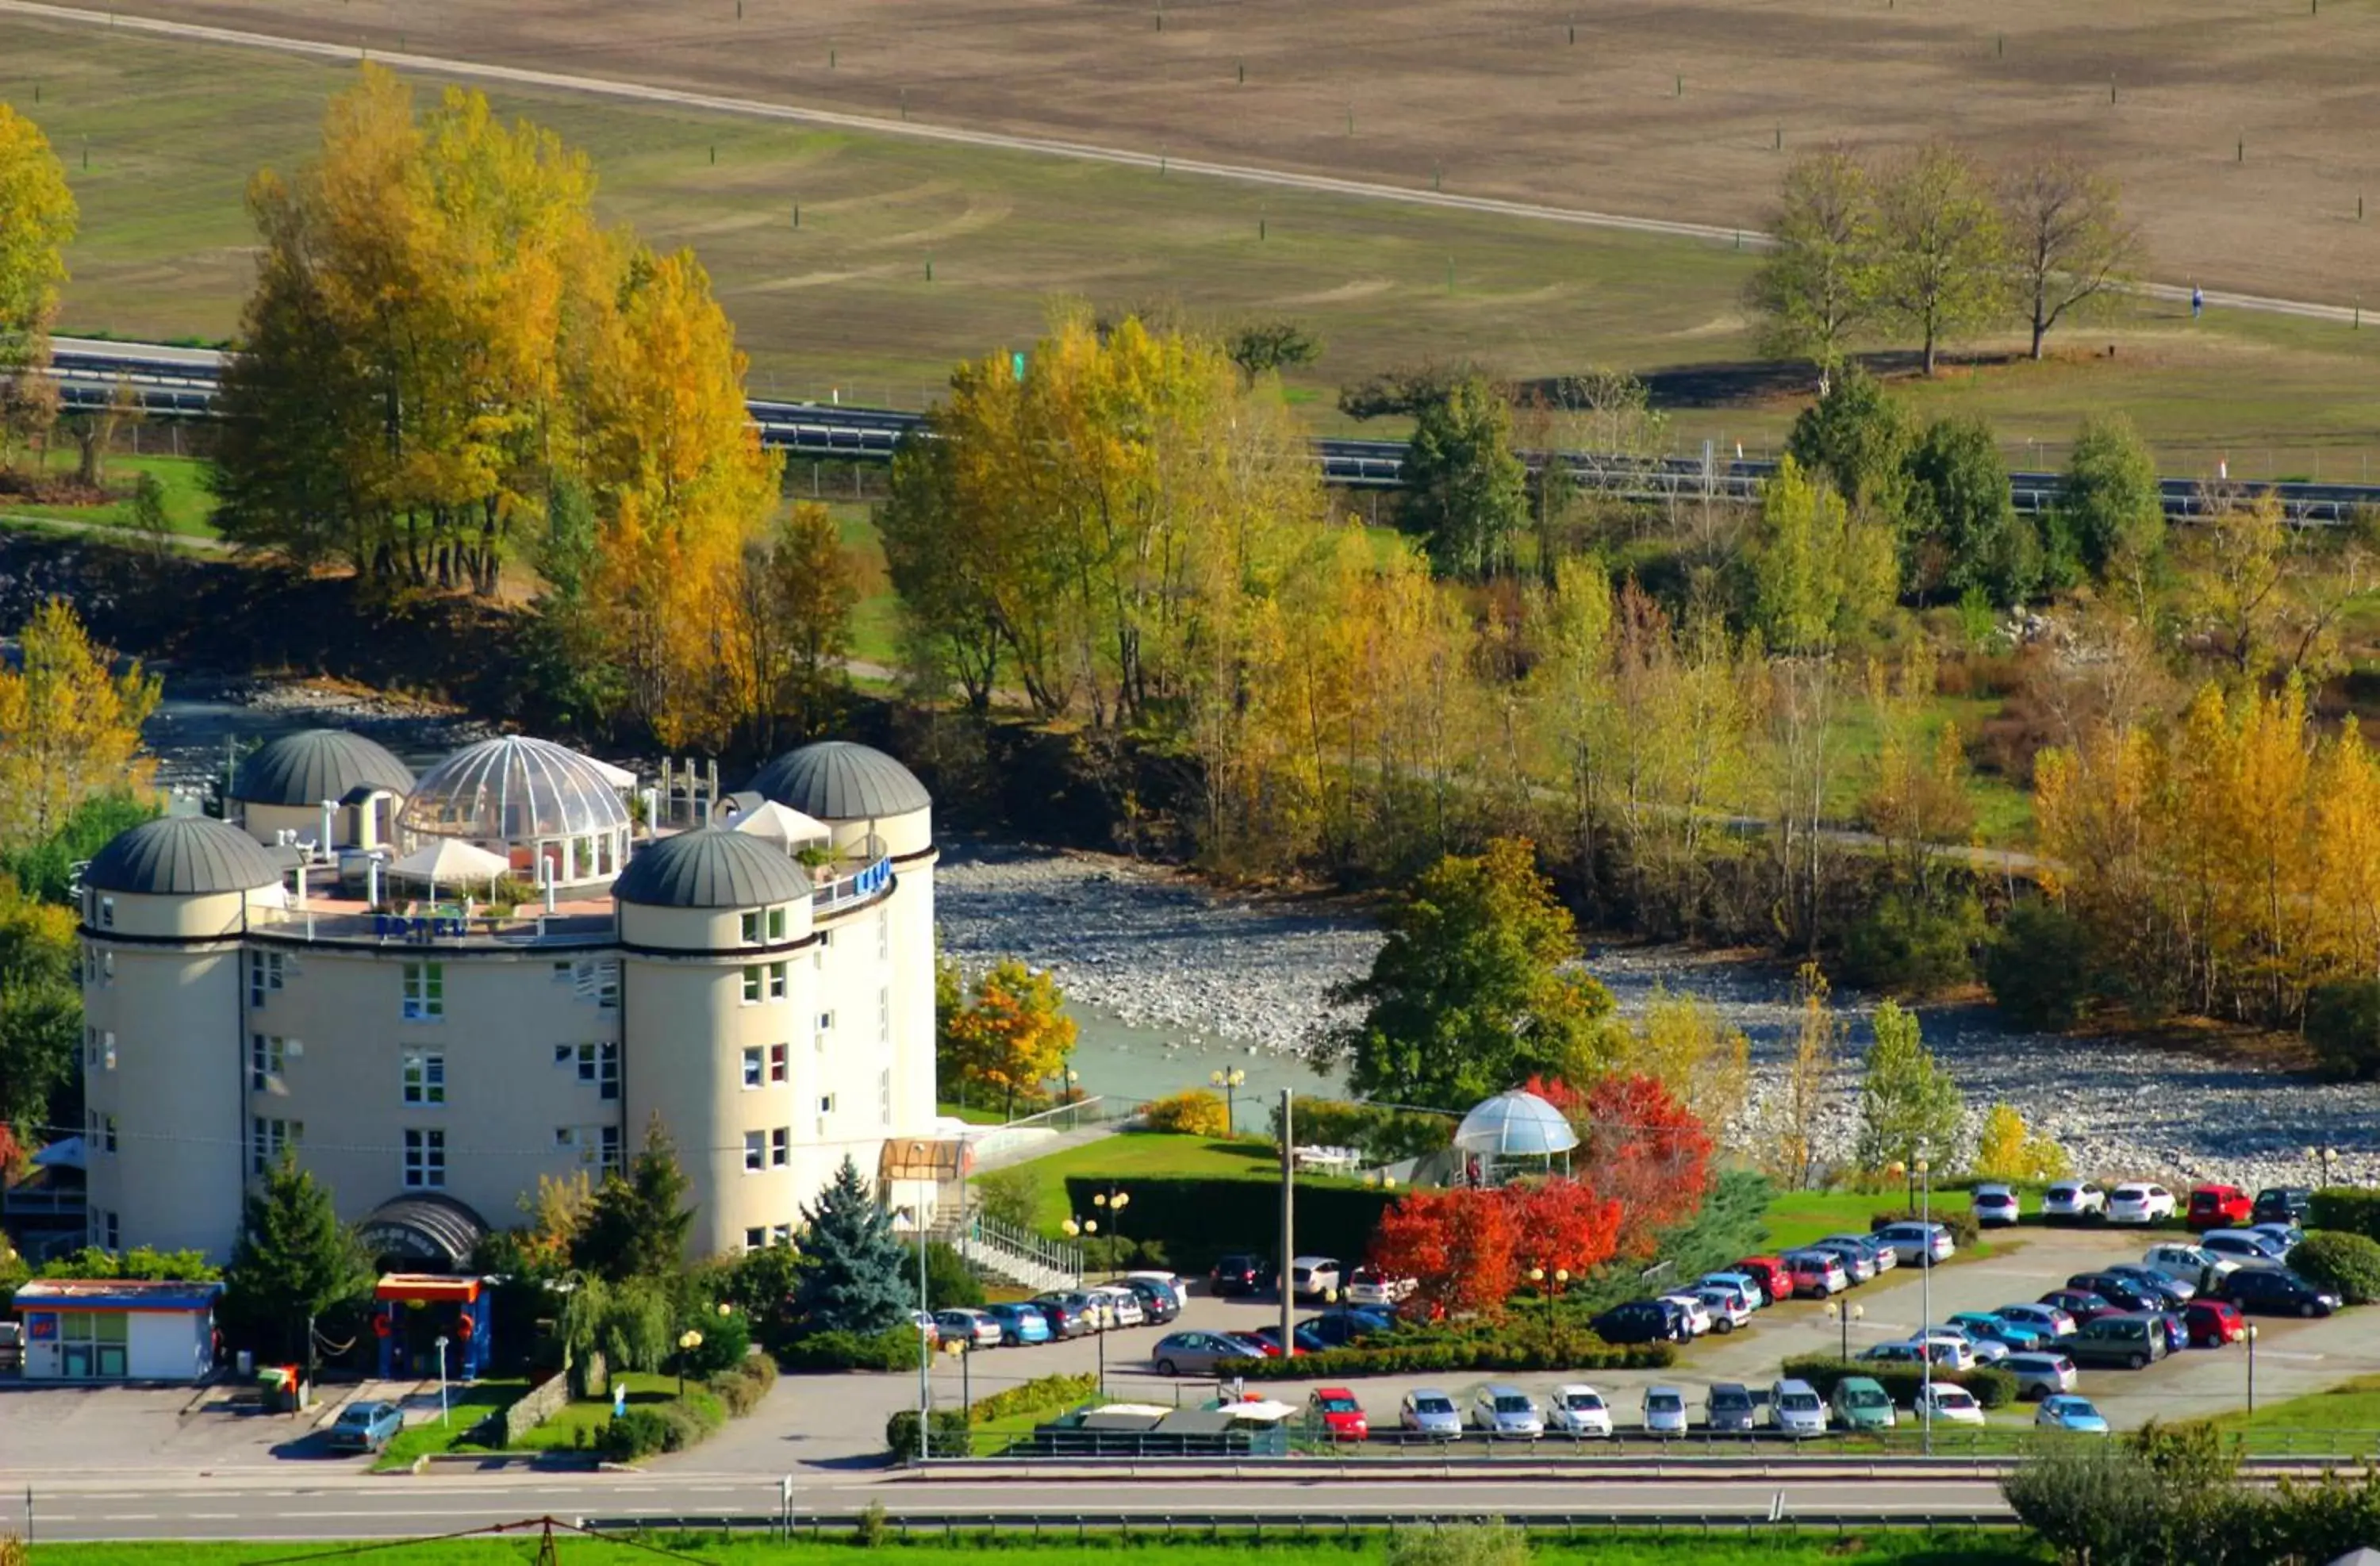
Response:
[397,735,628,888]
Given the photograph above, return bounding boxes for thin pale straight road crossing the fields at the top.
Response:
[0,0,2361,321]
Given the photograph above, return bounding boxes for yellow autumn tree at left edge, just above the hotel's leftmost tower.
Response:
[0,597,159,850]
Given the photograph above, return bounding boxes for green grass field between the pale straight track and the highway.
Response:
[13,15,2380,474]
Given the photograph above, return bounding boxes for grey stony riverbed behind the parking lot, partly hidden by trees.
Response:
[935,842,2380,1190]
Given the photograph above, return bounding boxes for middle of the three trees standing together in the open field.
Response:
[1875,143,2006,376]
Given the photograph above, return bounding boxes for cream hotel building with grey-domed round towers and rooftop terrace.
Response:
[81,731,935,1271]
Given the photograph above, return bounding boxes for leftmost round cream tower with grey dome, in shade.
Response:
[81,816,288,1261]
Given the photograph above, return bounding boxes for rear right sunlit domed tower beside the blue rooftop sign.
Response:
[752,740,935,1214]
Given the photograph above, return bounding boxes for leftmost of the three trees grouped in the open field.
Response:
[1747,148,1883,397]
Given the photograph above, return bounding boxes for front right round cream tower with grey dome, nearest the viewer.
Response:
[612,826,819,1257]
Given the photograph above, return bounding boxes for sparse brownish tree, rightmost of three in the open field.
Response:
[1999,148,2142,359]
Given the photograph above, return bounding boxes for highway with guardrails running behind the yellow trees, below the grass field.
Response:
[36,338,2380,524]
